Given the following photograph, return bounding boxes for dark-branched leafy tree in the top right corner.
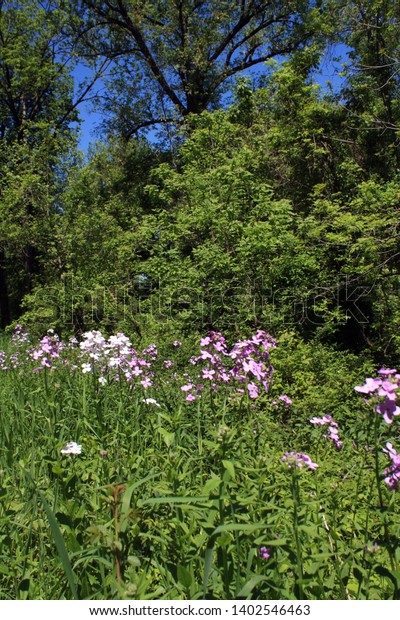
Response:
[340,0,400,174]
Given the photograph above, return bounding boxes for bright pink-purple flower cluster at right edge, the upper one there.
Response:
[354,368,400,424]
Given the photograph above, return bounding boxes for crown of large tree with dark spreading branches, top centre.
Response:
[80,0,329,135]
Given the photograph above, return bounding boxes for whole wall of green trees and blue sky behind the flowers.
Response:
[0,0,400,362]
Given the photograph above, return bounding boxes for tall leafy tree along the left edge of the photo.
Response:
[0,0,83,327]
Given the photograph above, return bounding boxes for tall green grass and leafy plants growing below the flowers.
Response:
[0,326,400,600]
